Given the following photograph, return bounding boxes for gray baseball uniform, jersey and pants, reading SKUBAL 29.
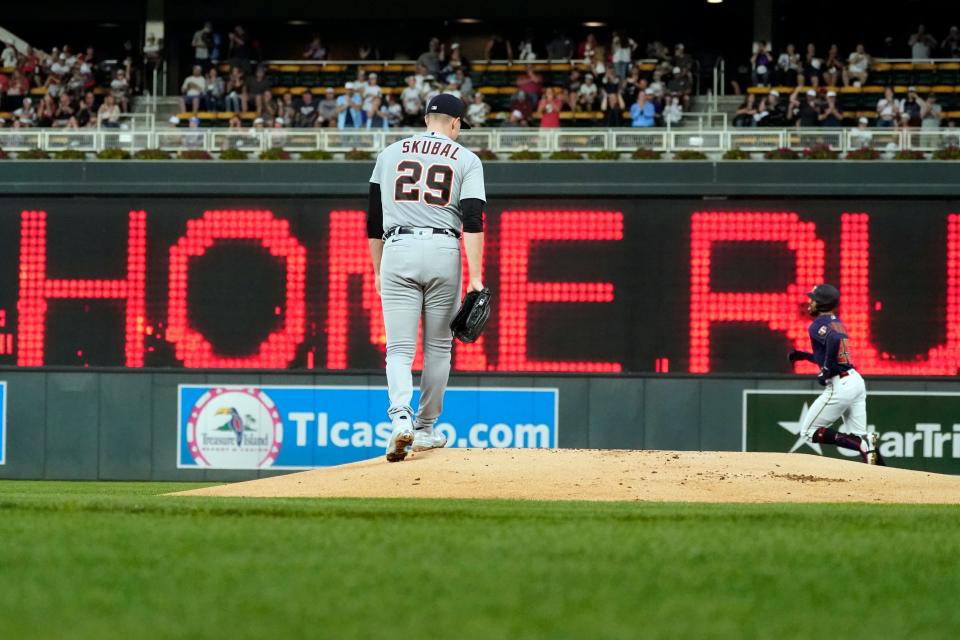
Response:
[370,131,486,428]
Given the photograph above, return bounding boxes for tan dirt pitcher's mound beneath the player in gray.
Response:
[176,449,960,504]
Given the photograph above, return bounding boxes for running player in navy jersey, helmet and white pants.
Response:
[790,284,884,465]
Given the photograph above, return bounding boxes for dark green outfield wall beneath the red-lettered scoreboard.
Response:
[0,370,960,480]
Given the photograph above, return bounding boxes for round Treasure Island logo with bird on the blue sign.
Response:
[187,388,283,469]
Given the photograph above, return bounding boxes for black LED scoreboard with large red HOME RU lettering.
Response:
[0,197,960,376]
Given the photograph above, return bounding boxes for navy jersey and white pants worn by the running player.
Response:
[800,314,867,441]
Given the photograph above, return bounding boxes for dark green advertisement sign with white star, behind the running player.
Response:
[743,389,960,473]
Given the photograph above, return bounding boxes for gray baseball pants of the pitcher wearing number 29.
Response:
[380,228,461,429]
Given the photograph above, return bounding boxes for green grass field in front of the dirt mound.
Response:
[0,481,960,640]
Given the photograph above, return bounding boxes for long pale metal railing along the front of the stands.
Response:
[0,126,960,154]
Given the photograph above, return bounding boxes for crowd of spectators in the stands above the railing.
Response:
[0,22,960,129]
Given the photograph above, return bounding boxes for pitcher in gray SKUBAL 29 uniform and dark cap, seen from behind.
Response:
[367,94,486,462]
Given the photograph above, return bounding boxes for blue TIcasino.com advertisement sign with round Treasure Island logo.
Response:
[177,385,558,469]
